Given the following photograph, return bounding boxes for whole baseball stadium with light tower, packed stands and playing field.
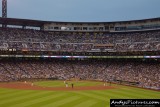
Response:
[0,0,160,107]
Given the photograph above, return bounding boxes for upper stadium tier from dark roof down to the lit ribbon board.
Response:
[0,17,160,58]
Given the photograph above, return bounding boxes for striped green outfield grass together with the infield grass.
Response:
[0,81,160,107]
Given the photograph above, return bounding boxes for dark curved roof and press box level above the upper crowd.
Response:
[0,17,160,32]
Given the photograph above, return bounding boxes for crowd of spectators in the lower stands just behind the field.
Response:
[0,60,160,89]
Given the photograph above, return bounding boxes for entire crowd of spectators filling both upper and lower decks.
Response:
[0,28,160,89]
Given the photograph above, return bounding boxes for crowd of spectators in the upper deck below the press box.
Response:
[0,28,160,51]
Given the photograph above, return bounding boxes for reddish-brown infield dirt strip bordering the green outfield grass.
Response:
[0,82,116,91]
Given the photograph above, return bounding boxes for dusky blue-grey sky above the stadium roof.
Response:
[0,0,160,22]
